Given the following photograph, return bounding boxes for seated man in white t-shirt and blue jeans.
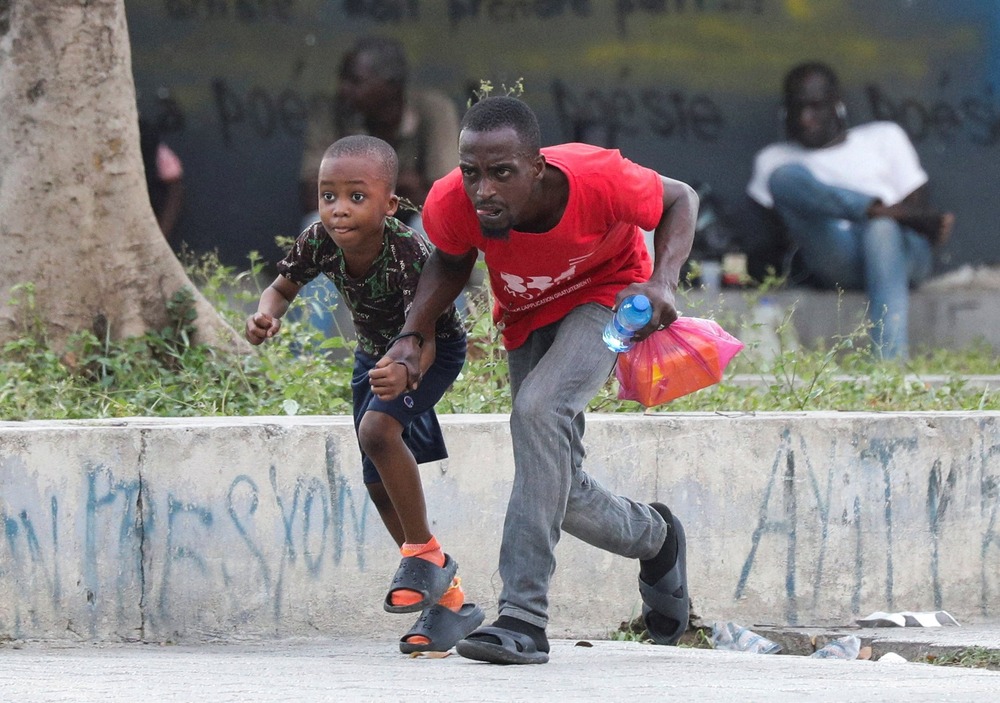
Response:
[747,63,955,359]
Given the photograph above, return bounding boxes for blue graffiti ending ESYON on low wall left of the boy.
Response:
[0,434,370,637]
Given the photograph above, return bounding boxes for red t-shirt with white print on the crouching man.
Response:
[423,144,663,349]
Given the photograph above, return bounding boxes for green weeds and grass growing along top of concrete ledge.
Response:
[0,254,1000,420]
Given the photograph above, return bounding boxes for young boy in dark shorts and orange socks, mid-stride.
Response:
[246,136,485,654]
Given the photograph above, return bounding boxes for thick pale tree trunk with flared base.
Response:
[0,0,248,349]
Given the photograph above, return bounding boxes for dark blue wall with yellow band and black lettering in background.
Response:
[126,0,1000,270]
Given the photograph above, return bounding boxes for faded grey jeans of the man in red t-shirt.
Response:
[499,303,667,628]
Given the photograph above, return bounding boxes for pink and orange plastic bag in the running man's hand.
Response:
[615,317,743,408]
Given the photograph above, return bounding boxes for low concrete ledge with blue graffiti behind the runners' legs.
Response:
[0,413,1000,641]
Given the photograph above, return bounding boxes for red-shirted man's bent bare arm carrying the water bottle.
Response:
[616,176,698,341]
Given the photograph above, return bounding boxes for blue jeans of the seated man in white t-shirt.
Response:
[768,164,933,359]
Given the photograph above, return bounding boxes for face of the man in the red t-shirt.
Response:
[458,127,545,239]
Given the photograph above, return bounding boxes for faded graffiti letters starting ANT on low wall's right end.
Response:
[733,430,1000,624]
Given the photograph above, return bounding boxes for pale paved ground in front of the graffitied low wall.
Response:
[0,627,1000,703]
